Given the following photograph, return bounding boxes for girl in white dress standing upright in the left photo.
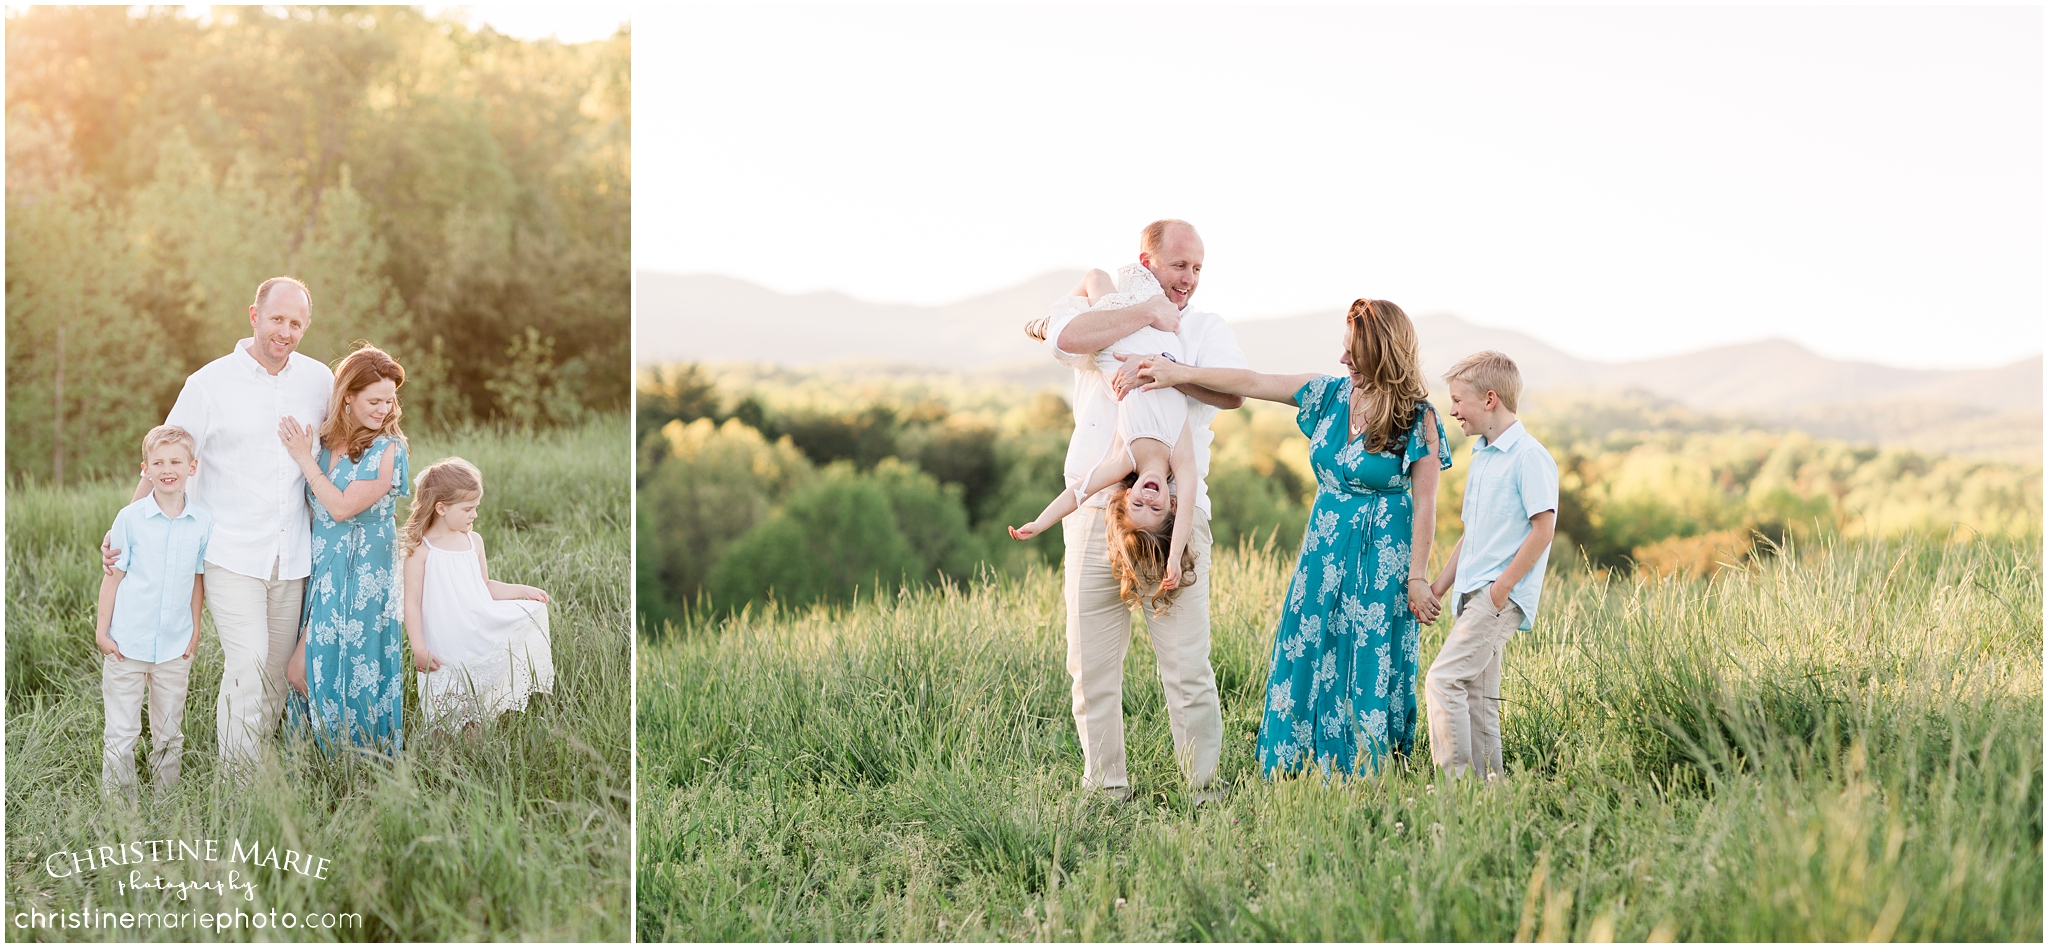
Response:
[403,457,555,727]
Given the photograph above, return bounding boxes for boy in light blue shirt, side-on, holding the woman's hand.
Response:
[1415,350,1556,780]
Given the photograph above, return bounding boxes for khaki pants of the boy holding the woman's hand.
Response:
[1425,584,1522,778]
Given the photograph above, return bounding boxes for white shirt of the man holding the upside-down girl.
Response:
[1044,297,1247,516]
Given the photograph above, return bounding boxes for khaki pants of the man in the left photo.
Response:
[207,563,305,764]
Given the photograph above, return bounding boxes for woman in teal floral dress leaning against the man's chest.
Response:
[279,346,412,756]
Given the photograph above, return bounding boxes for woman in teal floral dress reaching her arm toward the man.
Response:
[1141,299,1450,776]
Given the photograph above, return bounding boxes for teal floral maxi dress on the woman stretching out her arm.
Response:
[1260,375,1450,778]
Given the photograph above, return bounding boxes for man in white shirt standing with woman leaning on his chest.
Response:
[109,276,334,766]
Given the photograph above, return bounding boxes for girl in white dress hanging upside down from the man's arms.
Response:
[1010,264,1198,608]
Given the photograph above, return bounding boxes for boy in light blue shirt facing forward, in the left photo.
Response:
[96,424,213,799]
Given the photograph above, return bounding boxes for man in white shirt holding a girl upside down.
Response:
[1044,221,1245,805]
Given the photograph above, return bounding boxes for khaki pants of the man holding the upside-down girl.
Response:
[1061,508,1223,790]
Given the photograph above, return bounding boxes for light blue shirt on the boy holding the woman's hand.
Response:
[1452,422,1556,629]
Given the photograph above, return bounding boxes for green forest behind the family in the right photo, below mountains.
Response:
[635,364,2042,633]
